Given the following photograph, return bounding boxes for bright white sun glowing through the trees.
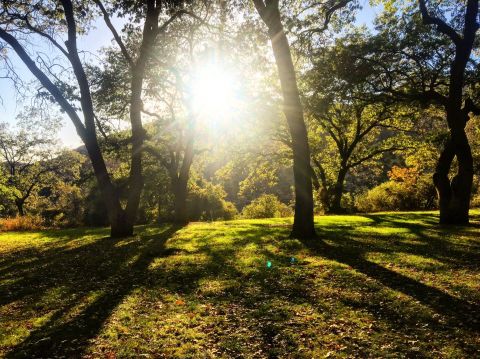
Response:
[191,64,238,126]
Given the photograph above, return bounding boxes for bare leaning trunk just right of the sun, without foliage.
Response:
[255,2,316,238]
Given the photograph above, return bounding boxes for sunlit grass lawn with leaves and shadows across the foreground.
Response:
[0,212,480,358]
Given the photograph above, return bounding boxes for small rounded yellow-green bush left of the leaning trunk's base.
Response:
[242,194,293,218]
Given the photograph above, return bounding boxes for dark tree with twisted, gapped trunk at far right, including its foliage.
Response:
[370,0,479,224]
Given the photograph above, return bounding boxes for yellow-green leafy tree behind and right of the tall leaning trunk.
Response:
[303,33,415,213]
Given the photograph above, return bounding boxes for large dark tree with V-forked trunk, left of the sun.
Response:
[0,0,193,237]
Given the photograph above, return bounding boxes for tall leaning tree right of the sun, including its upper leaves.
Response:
[253,0,357,238]
